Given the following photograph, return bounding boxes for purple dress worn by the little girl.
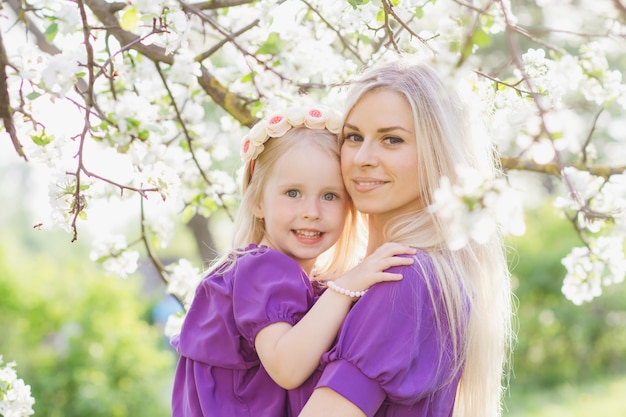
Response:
[172,245,317,417]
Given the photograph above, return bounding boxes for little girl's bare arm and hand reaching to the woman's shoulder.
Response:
[254,243,415,389]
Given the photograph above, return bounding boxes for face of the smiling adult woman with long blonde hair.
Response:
[341,89,422,221]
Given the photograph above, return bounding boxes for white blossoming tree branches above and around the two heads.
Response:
[0,0,626,316]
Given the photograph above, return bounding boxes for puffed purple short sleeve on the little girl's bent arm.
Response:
[233,248,314,346]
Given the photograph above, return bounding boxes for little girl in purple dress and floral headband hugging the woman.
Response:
[172,107,414,417]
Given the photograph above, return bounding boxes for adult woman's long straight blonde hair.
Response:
[346,62,512,417]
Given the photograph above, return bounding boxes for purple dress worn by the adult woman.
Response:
[291,252,460,417]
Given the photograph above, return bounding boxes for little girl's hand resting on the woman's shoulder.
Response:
[335,242,417,291]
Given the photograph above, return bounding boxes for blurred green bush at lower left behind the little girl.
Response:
[0,236,175,417]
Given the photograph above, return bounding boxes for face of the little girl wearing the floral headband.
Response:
[254,142,349,273]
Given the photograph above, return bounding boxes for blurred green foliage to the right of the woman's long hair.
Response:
[510,200,626,388]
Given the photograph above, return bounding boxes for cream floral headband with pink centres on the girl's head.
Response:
[240,106,342,175]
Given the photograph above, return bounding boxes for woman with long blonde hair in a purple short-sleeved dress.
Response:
[300,63,511,417]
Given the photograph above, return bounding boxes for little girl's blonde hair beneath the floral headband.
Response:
[206,126,358,278]
